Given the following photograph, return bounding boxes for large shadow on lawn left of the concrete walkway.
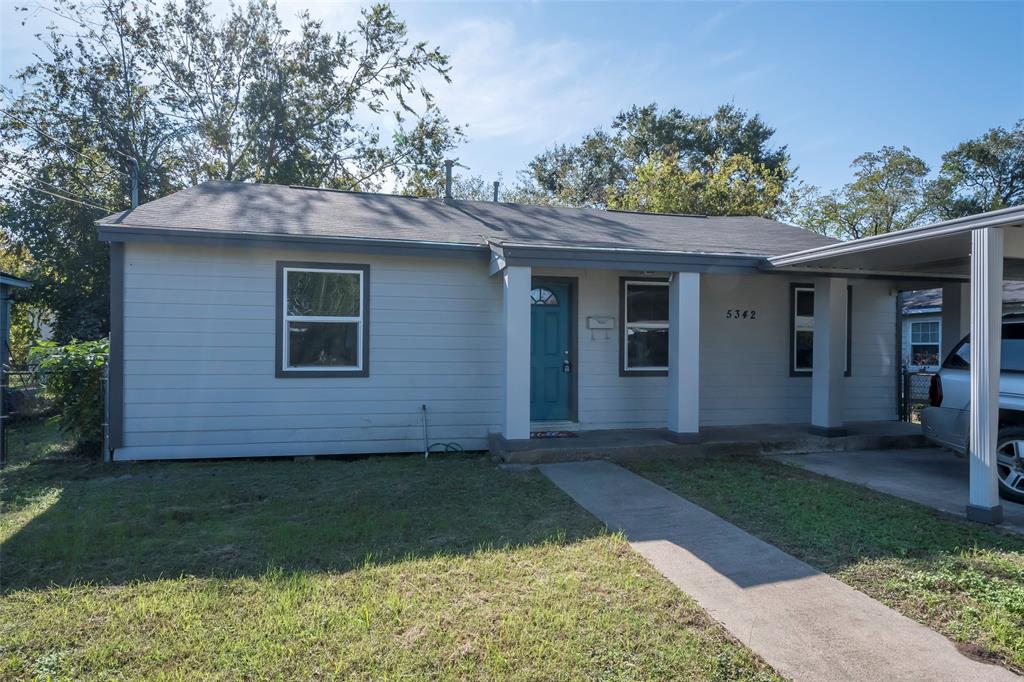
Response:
[0,436,604,593]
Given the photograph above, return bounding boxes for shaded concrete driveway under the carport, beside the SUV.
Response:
[773,447,1024,535]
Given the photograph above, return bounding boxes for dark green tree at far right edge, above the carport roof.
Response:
[928,119,1024,219]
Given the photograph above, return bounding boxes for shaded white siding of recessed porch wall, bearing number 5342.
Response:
[535,269,896,429]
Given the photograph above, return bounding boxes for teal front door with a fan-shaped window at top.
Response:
[529,279,574,421]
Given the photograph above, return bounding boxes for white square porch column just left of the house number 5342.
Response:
[668,272,700,442]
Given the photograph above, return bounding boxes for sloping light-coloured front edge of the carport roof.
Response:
[768,206,1024,267]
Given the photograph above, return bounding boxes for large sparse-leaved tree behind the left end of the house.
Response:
[0,0,462,339]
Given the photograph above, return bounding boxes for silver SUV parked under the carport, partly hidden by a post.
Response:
[921,314,1024,502]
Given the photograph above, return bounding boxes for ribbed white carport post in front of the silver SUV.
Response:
[967,227,1004,523]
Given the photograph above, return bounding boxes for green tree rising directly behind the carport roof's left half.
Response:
[785,146,929,240]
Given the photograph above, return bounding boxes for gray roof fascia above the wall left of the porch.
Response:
[97,223,487,259]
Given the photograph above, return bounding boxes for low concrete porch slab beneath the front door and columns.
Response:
[490,421,925,464]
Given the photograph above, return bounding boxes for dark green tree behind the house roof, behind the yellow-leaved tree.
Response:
[520,104,791,212]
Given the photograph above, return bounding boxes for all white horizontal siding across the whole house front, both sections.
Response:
[117,245,895,459]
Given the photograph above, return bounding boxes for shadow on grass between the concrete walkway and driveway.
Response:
[630,456,1024,572]
